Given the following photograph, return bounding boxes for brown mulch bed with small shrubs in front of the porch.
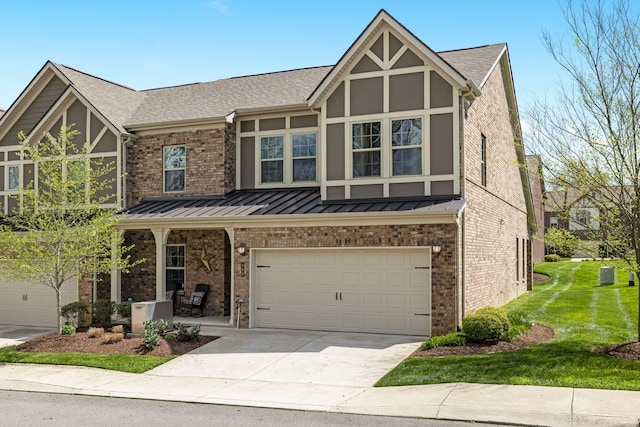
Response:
[16,331,218,357]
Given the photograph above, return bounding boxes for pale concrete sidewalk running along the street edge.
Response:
[0,364,640,426]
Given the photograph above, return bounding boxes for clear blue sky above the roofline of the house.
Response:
[0,0,592,115]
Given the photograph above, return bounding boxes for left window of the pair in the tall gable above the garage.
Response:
[351,122,381,177]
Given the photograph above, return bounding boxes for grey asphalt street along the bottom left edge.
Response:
[0,391,505,427]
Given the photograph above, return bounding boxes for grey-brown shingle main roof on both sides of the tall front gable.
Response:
[47,43,506,133]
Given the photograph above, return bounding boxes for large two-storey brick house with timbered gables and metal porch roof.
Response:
[0,11,535,335]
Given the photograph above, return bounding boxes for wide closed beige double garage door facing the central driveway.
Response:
[252,248,431,336]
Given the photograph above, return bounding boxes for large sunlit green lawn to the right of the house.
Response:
[376,261,640,390]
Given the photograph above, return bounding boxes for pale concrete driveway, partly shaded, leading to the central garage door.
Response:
[147,326,424,387]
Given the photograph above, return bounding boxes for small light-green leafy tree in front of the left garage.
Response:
[0,126,139,331]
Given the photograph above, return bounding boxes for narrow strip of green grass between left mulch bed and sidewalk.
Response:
[0,346,175,374]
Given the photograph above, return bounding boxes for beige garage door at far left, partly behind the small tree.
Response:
[0,280,78,328]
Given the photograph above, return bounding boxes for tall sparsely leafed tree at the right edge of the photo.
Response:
[527,0,640,341]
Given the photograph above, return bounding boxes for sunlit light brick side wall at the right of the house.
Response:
[463,56,530,314]
